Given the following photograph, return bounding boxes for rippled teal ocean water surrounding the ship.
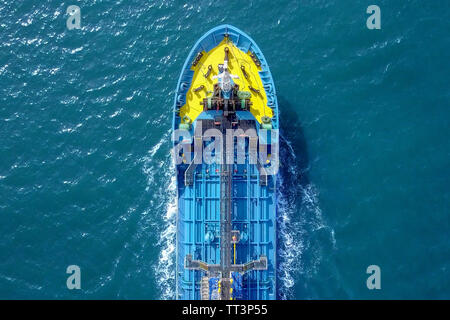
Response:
[0,0,450,299]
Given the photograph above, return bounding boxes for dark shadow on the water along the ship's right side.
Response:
[277,96,309,299]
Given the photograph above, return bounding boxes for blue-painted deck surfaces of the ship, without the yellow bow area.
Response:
[173,25,278,300]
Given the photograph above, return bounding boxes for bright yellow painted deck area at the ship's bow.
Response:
[180,39,273,123]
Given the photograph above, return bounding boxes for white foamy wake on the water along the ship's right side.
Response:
[277,135,334,299]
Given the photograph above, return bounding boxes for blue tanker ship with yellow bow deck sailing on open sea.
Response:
[173,25,279,300]
